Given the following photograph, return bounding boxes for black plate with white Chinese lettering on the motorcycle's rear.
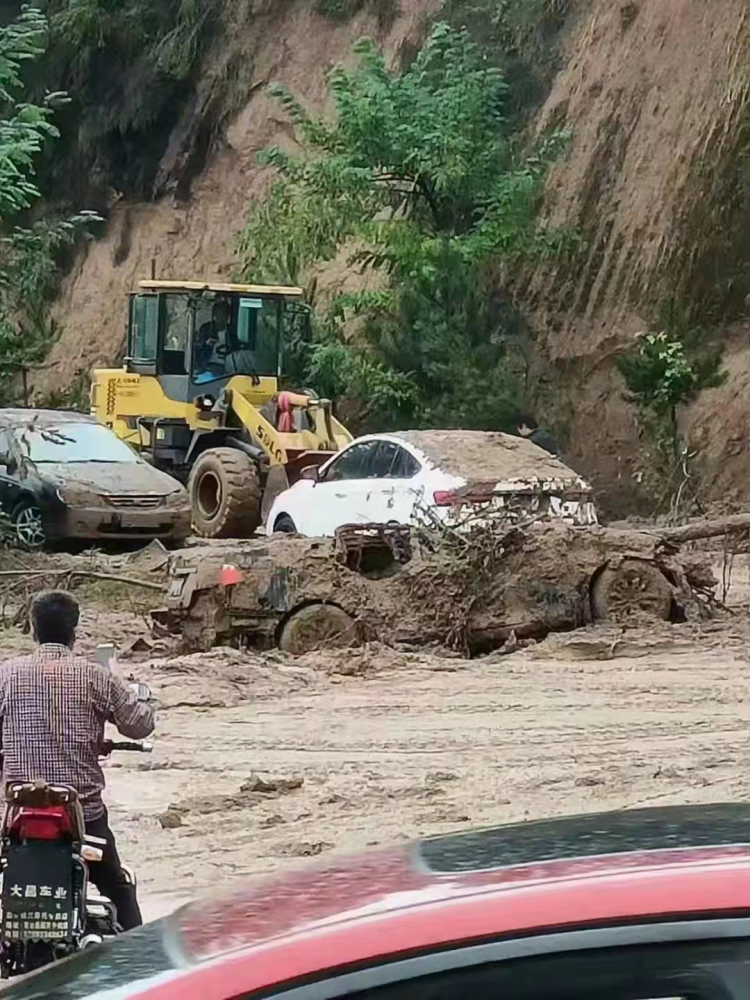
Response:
[0,842,74,941]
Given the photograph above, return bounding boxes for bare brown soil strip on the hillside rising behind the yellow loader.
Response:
[36,0,439,391]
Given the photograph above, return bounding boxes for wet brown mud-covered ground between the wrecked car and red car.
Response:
[0,557,750,916]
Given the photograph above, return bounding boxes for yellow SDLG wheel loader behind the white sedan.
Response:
[91,280,352,538]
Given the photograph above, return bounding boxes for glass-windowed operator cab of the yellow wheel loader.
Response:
[126,281,307,402]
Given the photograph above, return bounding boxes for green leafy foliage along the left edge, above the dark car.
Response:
[0,8,97,403]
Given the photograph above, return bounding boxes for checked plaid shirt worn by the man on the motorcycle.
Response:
[0,645,154,820]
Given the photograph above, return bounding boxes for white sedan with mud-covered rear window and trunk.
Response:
[266,431,597,536]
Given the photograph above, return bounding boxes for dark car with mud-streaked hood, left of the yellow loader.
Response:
[0,409,190,549]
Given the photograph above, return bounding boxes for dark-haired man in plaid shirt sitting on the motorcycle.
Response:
[0,591,154,930]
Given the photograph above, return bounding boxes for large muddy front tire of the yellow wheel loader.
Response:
[188,448,262,538]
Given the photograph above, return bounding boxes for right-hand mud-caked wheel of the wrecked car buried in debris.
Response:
[591,559,673,622]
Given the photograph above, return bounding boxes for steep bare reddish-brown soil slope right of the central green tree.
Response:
[528,0,750,497]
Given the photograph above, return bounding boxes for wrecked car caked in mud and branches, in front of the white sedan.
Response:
[163,520,715,653]
